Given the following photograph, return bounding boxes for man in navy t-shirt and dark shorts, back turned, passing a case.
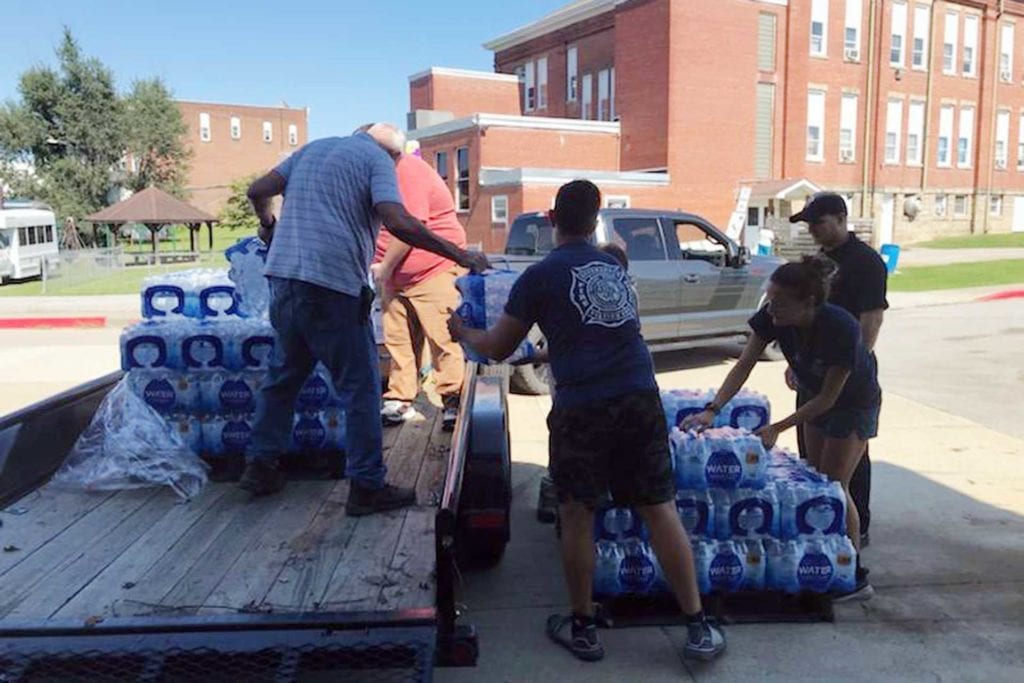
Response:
[450,180,725,661]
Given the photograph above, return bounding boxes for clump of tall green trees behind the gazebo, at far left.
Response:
[0,28,187,218]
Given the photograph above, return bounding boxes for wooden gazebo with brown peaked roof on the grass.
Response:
[86,187,217,254]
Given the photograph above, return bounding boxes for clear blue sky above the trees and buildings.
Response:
[0,0,568,137]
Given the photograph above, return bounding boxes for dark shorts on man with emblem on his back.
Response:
[548,391,676,508]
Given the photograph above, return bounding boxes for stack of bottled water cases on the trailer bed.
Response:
[121,238,345,478]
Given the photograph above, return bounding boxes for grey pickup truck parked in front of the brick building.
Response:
[490,209,784,394]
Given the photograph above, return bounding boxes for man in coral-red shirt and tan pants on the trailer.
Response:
[372,154,466,430]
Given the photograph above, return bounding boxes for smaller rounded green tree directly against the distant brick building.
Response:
[125,79,191,196]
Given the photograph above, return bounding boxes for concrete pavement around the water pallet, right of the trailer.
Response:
[436,351,1024,683]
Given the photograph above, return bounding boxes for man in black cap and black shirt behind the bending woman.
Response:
[786,193,889,547]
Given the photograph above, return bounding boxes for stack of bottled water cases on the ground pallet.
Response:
[594,390,856,597]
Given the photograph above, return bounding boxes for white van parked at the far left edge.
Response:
[0,209,60,281]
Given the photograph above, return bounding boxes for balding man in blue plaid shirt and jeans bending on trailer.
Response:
[240,124,487,516]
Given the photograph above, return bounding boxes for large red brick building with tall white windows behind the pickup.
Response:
[410,0,1024,248]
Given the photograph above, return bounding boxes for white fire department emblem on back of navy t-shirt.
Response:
[569,261,637,328]
